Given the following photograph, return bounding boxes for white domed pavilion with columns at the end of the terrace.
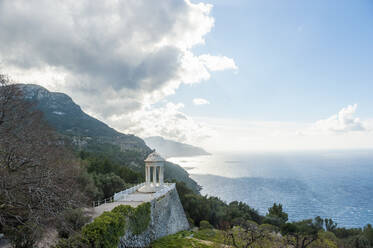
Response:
[138,152,165,193]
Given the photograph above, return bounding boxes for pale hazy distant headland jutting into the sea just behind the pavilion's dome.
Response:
[144,136,210,158]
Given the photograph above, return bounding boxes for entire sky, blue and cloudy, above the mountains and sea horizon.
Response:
[0,0,373,151]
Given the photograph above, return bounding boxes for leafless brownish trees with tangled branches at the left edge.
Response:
[0,75,82,246]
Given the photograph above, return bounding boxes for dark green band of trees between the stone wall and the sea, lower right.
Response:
[175,182,373,248]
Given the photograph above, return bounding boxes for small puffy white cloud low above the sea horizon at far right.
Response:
[313,104,366,133]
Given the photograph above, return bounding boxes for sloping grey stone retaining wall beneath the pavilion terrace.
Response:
[118,185,189,248]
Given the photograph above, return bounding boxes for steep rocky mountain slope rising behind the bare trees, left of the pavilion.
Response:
[19,84,151,153]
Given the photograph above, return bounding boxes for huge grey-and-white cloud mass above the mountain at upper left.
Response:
[0,0,237,141]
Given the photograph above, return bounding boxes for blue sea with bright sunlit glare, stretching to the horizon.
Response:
[168,151,373,227]
